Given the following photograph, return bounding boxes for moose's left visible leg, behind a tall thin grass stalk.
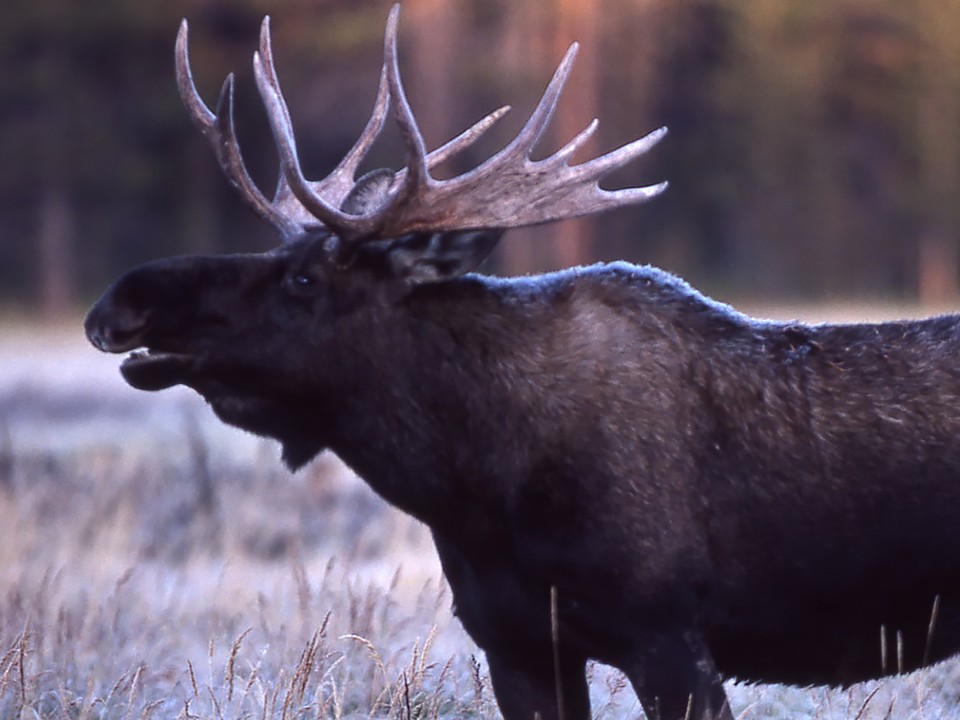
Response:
[487,651,590,720]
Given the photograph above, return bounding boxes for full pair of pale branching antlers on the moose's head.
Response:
[176,5,667,243]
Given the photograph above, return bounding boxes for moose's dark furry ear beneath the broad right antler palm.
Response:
[386,228,504,285]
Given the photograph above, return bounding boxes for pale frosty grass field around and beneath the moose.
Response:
[0,318,960,720]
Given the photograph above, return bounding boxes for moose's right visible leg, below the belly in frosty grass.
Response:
[622,632,733,720]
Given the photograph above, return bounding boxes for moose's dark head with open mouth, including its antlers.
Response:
[86,5,666,467]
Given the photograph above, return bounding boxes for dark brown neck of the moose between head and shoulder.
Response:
[318,277,568,524]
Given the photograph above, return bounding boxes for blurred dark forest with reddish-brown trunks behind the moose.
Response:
[0,0,960,316]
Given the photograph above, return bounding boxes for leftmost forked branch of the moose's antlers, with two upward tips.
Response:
[174,19,299,236]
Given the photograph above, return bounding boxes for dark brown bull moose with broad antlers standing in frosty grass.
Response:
[85,6,960,720]
